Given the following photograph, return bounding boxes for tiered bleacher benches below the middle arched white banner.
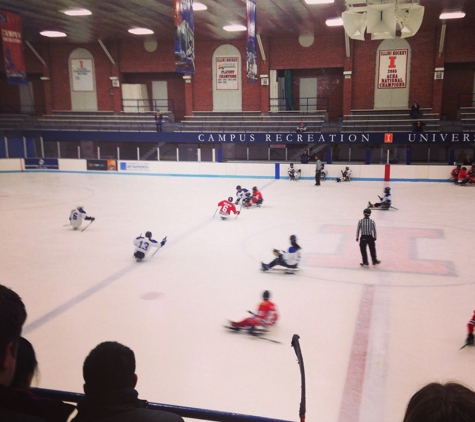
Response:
[177,111,327,133]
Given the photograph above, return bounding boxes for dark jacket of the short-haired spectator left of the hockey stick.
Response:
[71,388,183,422]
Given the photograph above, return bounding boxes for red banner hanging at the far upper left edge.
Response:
[0,10,28,85]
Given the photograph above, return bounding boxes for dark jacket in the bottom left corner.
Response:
[0,385,74,422]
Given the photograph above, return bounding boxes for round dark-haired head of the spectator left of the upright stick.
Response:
[83,341,137,395]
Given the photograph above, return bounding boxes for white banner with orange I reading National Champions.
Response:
[378,49,408,89]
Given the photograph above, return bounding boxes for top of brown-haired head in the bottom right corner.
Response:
[403,382,475,422]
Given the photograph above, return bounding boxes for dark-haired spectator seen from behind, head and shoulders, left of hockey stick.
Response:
[72,341,183,422]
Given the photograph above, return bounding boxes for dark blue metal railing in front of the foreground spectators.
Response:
[31,388,290,422]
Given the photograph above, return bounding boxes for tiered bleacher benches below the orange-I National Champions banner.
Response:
[341,109,440,132]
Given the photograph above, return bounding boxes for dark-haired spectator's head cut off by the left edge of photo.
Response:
[0,285,26,386]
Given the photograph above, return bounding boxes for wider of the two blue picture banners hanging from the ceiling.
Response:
[175,0,195,73]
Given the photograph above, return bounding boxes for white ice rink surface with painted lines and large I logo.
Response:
[0,172,475,422]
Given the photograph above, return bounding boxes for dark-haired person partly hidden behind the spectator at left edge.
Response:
[9,337,75,422]
